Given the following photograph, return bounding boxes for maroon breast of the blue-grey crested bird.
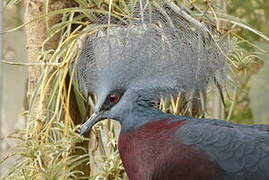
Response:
[118,120,222,180]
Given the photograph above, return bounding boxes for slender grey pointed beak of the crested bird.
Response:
[80,112,105,135]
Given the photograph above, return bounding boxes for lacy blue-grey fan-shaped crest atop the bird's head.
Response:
[77,19,225,101]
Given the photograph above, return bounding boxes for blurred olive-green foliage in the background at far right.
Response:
[227,0,269,124]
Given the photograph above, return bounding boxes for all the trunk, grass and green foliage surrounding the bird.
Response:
[0,0,269,180]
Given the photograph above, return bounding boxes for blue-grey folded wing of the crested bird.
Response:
[177,120,269,180]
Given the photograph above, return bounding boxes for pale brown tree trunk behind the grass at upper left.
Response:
[25,0,71,120]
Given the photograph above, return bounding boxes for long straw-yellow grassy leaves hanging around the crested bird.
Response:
[1,0,268,180]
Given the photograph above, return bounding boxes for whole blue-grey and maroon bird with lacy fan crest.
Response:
[76,0,269,180]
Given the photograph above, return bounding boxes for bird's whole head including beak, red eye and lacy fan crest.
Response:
[76,8,225,134]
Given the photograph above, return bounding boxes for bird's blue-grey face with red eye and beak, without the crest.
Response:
[80,82,159,134]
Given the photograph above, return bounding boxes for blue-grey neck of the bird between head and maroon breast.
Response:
[121,107,180,133]
